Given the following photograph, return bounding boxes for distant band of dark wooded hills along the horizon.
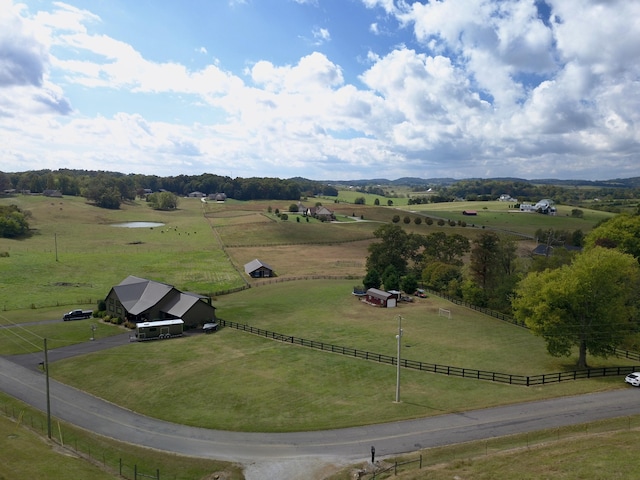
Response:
[0,169,640,210]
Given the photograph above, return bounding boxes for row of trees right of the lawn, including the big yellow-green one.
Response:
[363,213,640,368]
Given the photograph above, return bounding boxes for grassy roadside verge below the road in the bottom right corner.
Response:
[327,416,640,480]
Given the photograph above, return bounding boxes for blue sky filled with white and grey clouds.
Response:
[0,0,640,180]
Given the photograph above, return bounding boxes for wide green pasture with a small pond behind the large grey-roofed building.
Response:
[0,196,244,311]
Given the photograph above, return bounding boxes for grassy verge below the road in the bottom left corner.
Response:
[0,393,244,480]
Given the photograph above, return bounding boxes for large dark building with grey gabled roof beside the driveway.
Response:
[105,275,216,328]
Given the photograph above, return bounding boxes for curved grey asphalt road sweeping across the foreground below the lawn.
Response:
[0,336,640,478]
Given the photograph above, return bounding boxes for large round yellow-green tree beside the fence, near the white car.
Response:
[512,247,640,368]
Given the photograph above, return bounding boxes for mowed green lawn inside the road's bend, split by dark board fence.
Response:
[51,281,625,431]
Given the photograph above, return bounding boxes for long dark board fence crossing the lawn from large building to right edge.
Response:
[218,319,640,387]
